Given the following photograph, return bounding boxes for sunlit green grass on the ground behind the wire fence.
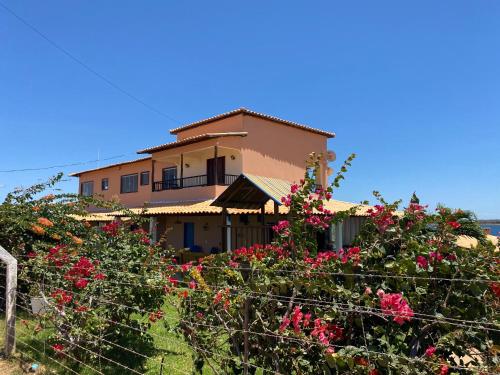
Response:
[0,299,212,375]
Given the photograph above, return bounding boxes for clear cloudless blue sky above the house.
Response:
[0,0,500,218]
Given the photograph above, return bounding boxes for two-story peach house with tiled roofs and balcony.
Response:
[73,108,366,253]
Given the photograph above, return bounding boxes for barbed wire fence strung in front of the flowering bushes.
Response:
[0,250,500,374]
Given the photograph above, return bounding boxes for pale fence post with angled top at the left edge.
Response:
[0,246,17,357]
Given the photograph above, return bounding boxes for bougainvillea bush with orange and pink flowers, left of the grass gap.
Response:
[0,176,179,373]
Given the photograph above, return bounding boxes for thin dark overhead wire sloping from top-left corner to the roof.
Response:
[0,2,180,124]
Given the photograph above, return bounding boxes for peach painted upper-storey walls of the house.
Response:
[74,109,328,207]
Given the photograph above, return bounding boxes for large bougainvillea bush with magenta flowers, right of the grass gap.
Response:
[172,155,500,375]
